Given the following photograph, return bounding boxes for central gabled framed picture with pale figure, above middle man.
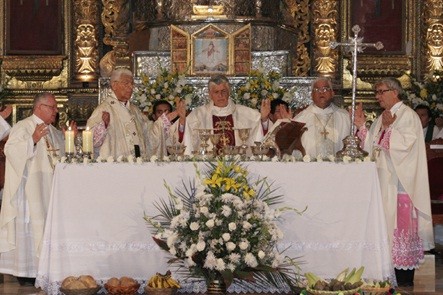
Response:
[191,25,231,75]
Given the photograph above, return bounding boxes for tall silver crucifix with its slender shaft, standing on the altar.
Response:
[330,25,383,136]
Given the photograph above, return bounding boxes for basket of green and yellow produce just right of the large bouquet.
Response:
[305,266,364,295]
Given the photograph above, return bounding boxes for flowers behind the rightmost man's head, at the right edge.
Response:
[406,71,443,118]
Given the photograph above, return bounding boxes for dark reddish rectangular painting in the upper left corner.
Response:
[5,0,64,55]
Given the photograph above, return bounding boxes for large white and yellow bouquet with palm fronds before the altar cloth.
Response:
[145,160,304,290]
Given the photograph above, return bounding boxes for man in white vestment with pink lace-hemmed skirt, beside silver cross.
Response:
[355,78,434,286]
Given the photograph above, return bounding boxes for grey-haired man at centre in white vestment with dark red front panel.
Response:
[184,75,268,155]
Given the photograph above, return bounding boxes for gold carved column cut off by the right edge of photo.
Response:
[424,0,443,73]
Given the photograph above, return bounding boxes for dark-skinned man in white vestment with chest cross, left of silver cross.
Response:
[293,77,351,157]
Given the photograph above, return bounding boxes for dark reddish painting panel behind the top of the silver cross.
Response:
[351,0,406,54]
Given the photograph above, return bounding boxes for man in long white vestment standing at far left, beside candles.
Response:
[0,92,72,284]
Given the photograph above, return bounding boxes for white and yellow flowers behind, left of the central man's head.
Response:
[132,68,198,113]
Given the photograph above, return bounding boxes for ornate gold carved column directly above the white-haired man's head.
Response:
[101,0,131,68]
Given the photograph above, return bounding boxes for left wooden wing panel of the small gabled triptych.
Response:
[171,25,190,74]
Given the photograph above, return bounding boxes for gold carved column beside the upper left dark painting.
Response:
[73,0,99,82]
